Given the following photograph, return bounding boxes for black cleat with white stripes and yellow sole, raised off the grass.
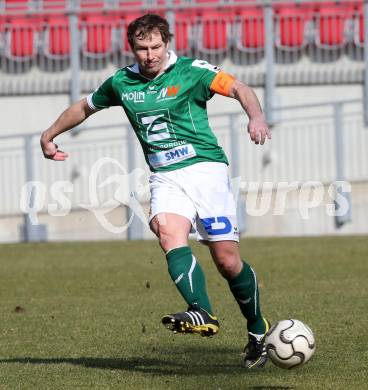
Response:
[162,305,220,337]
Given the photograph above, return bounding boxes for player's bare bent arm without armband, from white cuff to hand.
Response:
[40,98,96,161]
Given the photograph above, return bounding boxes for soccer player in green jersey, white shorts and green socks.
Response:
[41,14,271,369]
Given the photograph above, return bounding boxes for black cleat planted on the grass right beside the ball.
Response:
[242,318,271,369]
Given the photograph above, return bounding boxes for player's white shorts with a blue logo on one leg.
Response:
[149,162,239,242]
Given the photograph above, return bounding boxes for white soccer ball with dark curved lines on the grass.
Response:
[265,319,316,369]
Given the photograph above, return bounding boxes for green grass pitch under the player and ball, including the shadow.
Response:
[0,236,368,390]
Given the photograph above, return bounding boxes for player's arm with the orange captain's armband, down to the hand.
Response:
[210,71,271,145]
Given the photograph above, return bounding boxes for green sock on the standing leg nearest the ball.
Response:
[228,261,266,334]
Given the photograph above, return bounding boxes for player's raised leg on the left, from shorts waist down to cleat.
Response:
[150,169,219,336]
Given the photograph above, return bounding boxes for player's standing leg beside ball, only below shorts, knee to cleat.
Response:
[206,240,269,368]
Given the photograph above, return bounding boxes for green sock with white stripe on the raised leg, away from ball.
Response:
[166,246,212,315]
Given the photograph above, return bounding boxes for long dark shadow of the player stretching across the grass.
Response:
[0,348,262,375]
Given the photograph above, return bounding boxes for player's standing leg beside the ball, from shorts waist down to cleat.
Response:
[186,159,268,368]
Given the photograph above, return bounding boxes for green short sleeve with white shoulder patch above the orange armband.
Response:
[191,60,220,100]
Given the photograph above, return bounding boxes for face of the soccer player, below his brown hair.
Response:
[132,30,168,78]
